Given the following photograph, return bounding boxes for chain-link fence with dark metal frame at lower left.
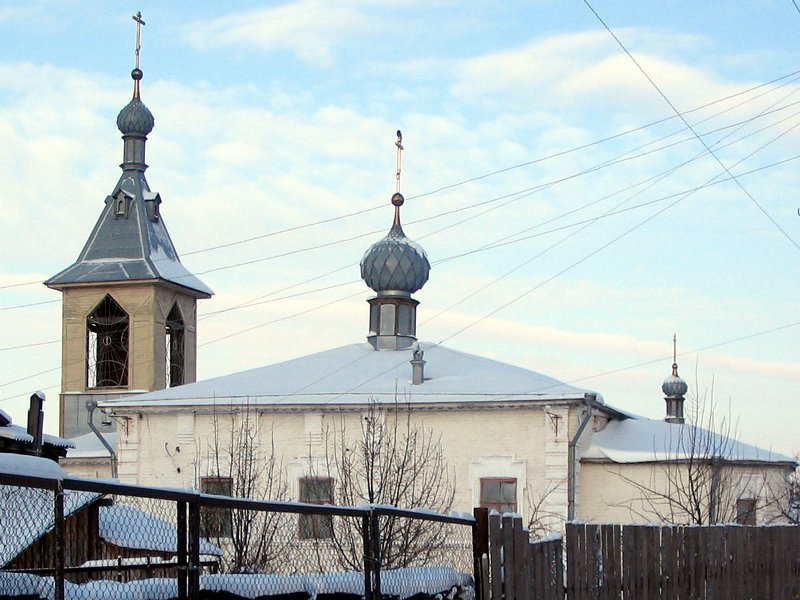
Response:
[0,474,475,600]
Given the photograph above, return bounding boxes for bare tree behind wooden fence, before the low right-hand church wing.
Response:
[620,380,776,525]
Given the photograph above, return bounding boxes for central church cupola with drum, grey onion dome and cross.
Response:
[361,130,431,350]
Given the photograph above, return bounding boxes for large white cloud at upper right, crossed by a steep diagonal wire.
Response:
[452,29,731,118]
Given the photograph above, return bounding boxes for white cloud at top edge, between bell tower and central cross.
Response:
[186,0,376,66]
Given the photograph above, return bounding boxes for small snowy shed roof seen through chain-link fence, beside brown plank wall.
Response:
[99,504,222,556]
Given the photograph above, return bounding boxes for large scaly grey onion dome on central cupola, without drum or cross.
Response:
[361,193,431,294]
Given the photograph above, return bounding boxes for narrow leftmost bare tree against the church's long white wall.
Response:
[200,406,290,572]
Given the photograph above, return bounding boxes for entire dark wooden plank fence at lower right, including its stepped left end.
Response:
[476,511,800,600]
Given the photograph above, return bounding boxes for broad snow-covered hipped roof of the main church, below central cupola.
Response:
[101,343,600,407]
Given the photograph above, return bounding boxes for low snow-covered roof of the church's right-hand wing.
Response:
[581,418,795,464]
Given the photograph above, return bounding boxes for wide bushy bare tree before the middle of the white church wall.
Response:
[324,401,455,569]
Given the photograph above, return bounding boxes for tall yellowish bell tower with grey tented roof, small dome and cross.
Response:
[45,13,213,438]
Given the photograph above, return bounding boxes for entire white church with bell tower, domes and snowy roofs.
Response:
[53,28,795,532]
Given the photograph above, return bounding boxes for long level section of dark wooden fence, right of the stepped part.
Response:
[566,523,800,600]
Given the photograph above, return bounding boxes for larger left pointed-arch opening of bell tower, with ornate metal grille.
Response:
[86,296,130,388]
